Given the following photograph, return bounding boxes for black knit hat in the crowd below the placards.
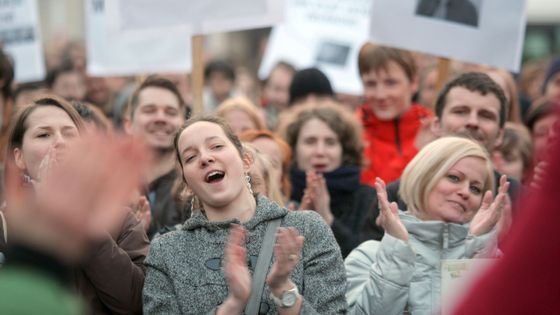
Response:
[290,68,334,105]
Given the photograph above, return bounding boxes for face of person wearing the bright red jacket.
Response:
[362,61,418,120]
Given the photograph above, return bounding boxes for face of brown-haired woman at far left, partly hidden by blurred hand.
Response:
[13,106,79,179]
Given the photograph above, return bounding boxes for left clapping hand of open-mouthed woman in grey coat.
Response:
[218,224,251,314]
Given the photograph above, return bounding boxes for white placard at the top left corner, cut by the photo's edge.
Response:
[0,0,45,82]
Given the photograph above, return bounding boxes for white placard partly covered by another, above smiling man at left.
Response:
[86,0,192,76]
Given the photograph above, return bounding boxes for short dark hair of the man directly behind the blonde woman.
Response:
[435,72,507,128]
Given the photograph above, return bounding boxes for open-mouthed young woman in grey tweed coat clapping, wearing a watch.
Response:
[144,116,346,315]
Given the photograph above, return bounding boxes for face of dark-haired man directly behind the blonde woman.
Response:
[434,86,503,152]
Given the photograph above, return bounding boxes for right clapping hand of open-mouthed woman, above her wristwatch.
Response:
[266,227,304,296]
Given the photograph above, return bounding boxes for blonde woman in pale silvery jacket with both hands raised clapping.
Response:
[345,137,508,315]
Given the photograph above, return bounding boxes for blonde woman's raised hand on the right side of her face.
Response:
[469,175,509,236]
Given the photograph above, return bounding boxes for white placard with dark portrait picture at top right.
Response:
[370,0,526,72]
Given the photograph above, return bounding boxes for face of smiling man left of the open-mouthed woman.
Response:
[128,87,185,150]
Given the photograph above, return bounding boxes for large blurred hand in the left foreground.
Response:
[2,135,148,261]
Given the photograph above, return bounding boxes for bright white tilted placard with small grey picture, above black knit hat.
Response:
[259,0,371,95]
